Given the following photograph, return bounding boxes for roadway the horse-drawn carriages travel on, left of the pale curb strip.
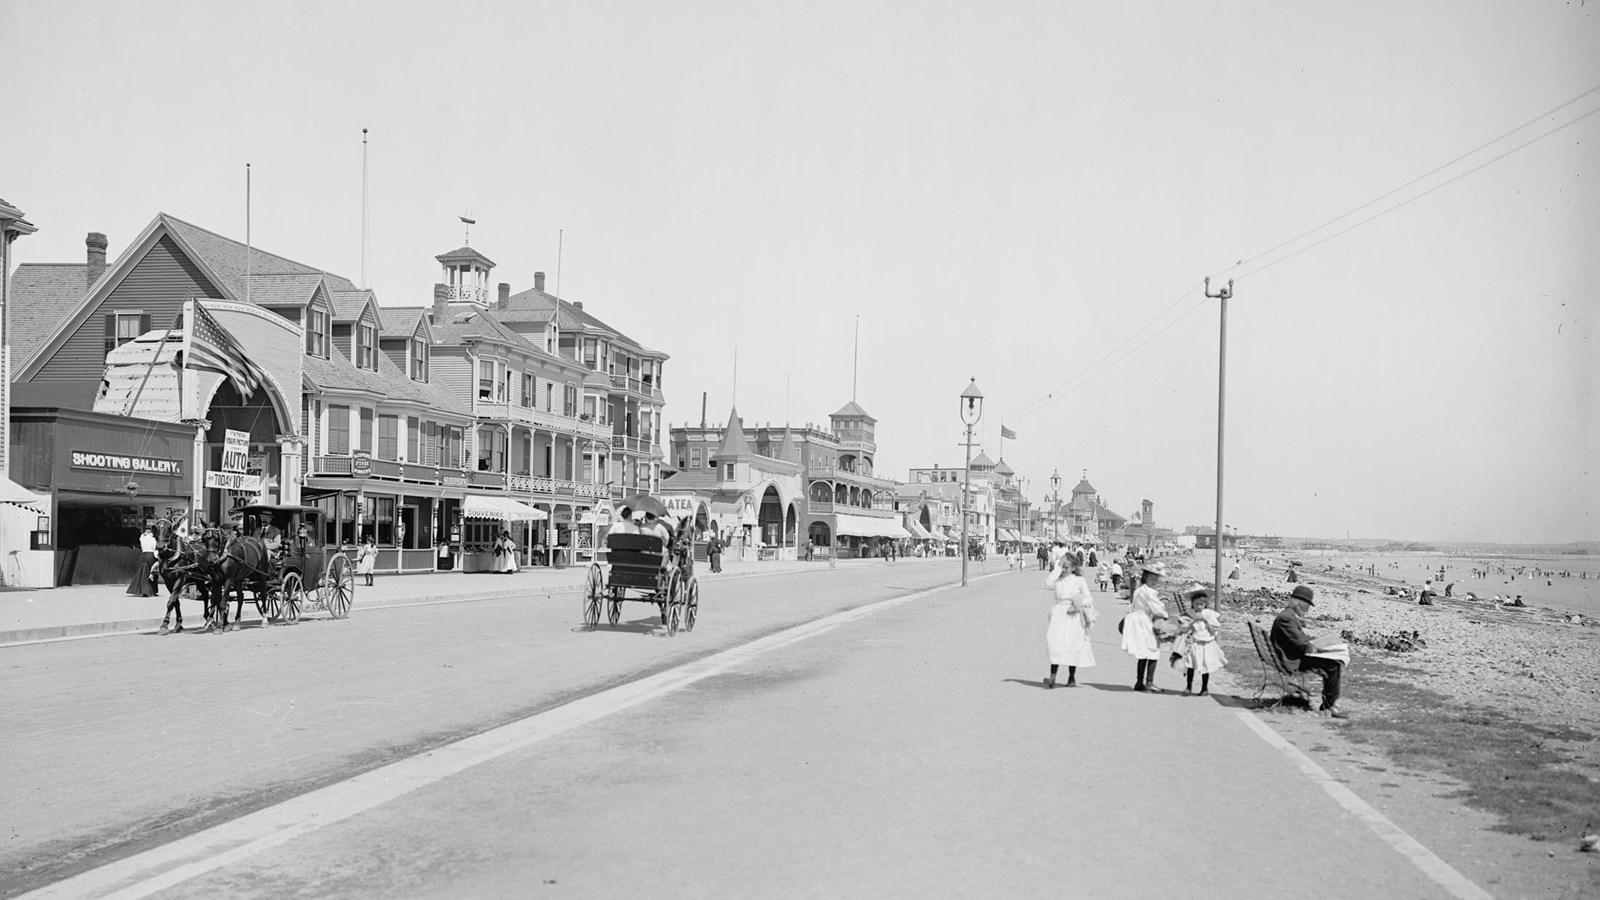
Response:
[0,560,957,892]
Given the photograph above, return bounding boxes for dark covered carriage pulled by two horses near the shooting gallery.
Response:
[235,503,355,621]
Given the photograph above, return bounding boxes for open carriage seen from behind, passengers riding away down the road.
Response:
[584,506,699,636]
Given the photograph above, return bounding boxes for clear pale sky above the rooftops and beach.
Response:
[0,0,1600,543]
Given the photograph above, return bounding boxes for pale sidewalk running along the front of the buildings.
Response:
[0,559,870,647]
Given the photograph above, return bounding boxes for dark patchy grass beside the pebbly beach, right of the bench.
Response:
[1342,660,1600,844]
